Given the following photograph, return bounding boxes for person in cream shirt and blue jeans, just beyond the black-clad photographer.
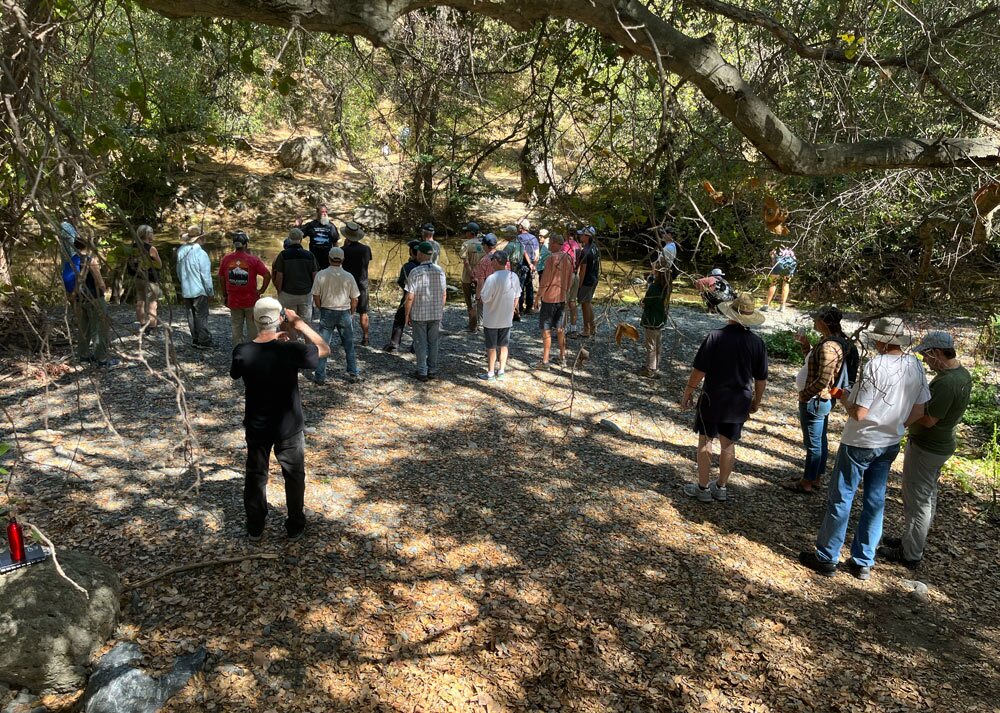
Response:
[313,247,361,384]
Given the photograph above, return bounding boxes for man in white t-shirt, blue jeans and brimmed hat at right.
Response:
[799,318,931,579]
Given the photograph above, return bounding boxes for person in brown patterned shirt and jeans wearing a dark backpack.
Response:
[781,305,858,494]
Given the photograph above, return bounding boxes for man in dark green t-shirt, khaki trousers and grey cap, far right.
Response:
[878,332,972,569]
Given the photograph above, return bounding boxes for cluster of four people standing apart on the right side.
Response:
[681,295,972,580]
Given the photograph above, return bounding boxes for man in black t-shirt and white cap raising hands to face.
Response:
[229,297,330,542]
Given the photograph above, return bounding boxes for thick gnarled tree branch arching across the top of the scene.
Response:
[139,0,1000,176]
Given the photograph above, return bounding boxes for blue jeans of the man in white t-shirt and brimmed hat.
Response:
[816,443,899,567]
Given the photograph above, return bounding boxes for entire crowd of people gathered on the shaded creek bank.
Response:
[64,211,972,579]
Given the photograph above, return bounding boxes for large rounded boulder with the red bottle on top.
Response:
[0,551,122,693]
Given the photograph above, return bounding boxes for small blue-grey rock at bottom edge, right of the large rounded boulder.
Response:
[81,642,208,713]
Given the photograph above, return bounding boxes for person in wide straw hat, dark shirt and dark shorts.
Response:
[681,294,768,503]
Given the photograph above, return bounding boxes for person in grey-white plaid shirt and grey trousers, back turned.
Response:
[405,240,448,381]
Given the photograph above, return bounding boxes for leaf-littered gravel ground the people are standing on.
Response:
[0,307,1000,713]
